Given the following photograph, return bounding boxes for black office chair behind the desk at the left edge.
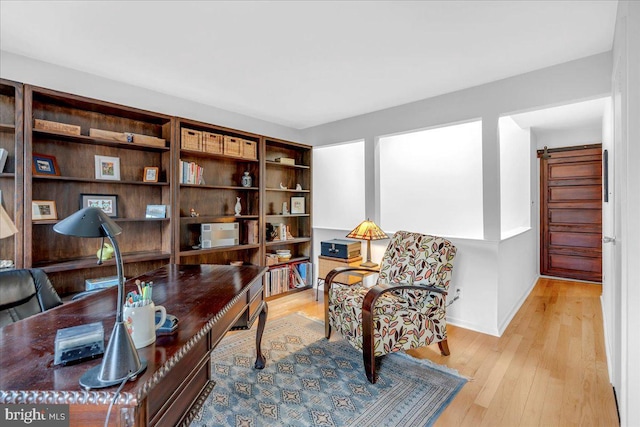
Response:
[0,269,62,328]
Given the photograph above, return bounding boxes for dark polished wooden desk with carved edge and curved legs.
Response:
[0,265,267,427]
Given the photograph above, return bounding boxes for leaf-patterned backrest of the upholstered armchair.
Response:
[378,231,456,292]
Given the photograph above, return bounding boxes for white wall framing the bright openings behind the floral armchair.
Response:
[302,53,611,335]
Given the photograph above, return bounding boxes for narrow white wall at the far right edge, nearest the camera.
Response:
[604,1,640,426]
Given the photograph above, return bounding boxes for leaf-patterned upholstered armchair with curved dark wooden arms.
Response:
[324,231,456,383]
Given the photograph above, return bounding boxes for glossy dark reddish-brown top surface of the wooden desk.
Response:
[0,264,266,403]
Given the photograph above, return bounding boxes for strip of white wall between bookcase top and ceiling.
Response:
[0,51,301,141]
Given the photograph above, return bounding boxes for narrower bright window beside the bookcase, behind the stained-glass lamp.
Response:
[313,140,365,230]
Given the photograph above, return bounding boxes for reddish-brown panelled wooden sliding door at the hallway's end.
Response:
[540,145,602,282]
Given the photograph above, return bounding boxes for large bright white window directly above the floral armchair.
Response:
[378,121,483,239]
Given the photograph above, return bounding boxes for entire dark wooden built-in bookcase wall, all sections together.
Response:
[6,80,312,297]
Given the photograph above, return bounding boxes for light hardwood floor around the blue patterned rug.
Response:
[267,278,619,427]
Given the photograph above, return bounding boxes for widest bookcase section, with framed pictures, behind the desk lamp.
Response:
[24,85,173,295]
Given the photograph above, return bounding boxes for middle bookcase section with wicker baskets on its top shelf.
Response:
[173,119,262,265]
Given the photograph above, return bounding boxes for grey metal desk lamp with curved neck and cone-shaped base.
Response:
[53,208,147,389]
